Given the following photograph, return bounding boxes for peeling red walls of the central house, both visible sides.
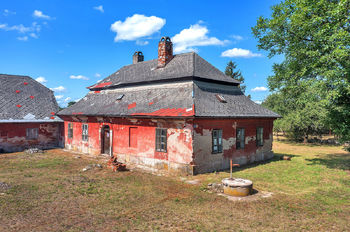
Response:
[62,116,273,174]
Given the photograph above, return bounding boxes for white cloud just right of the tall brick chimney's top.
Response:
[171,23,228,53]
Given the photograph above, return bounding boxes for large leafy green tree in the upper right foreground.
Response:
[252,0,350,147]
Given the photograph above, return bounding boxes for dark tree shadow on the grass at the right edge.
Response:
[306,153,350,171]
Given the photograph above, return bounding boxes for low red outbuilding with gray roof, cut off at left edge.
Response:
[0,74,64,152]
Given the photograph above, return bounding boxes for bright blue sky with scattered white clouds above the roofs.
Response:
[0,0,280,106]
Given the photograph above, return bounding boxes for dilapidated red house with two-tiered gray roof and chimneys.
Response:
[58,37,279,174]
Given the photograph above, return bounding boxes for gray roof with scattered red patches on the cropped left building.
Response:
[0,74,61,122]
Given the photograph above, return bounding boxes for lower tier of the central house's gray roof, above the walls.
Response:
[59,81,280,118]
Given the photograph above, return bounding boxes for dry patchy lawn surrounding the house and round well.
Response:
[0,142,350,231]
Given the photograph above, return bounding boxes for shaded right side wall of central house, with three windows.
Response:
[193,119,273,173]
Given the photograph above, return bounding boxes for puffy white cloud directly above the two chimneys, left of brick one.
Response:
[111,14,166,42]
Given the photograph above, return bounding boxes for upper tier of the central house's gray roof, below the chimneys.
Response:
[90,52,239,89]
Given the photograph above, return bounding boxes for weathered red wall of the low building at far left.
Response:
[0,122,64,152]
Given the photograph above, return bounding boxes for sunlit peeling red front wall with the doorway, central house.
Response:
[64,116,193,173]
